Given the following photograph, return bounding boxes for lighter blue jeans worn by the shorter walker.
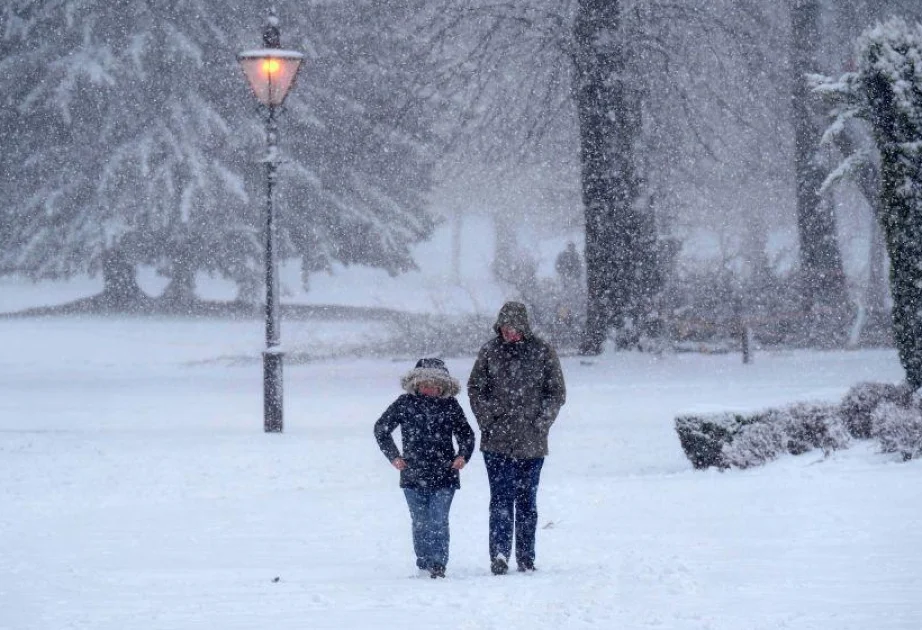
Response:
[403,488,455,569]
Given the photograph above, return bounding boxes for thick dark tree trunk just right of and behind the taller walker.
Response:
[574,0,643,355]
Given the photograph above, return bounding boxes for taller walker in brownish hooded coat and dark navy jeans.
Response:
[467,302,566,575]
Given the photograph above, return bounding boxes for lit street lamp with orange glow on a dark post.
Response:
[237,10,304,433]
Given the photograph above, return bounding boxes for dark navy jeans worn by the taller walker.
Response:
[483,452,544,563]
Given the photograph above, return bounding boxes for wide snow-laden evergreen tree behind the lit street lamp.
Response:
[0,0,433,305]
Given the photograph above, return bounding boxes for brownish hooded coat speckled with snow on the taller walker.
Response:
[467,302,567,459]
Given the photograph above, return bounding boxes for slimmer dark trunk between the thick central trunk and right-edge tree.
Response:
[791,0,850,341]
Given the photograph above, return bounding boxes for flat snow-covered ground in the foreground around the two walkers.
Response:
[0,319,922,630]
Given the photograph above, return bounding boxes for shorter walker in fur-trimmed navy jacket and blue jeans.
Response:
[375,359,474,578]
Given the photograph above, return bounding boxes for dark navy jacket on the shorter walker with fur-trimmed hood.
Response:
[375,371,474,490]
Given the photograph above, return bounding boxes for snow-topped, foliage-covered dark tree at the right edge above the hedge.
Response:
[814,18,922,389]
